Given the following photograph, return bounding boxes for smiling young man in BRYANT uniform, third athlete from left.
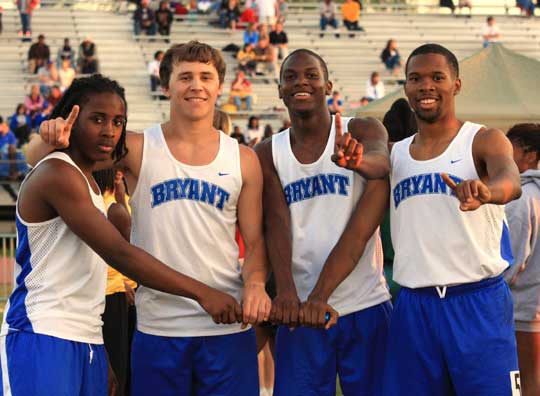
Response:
[257,49,391,396]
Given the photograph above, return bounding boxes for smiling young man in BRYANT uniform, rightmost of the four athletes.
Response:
[384,44,521,396]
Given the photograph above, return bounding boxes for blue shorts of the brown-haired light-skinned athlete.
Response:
[131,330,259,396]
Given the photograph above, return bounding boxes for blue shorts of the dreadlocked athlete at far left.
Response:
[0,332,107,396]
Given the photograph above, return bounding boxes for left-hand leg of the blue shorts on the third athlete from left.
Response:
[274,320,339,396]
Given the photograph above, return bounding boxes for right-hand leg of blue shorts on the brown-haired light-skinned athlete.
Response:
[193,329,259,396]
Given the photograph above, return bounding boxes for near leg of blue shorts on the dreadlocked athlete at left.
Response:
[0,332,87,396]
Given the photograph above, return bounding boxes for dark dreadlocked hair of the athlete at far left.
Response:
[50,74,128,161]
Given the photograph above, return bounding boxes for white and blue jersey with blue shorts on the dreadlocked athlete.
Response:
[0,152,107,396]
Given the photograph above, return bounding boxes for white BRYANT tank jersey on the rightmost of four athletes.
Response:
[390,122,512,288]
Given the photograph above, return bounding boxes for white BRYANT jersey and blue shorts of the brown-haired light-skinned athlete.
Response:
[130,125,258,396]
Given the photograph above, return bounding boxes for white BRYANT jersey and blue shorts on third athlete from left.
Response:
[272,117,391,396]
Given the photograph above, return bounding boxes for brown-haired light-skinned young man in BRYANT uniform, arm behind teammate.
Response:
[31,42,270,396]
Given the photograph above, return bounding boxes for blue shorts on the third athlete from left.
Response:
[274,301,392,396]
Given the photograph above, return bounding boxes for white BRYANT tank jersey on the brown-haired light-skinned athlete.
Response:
[130,125,243,337]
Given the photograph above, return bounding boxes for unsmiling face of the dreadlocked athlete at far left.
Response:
[70,92,126,162]
